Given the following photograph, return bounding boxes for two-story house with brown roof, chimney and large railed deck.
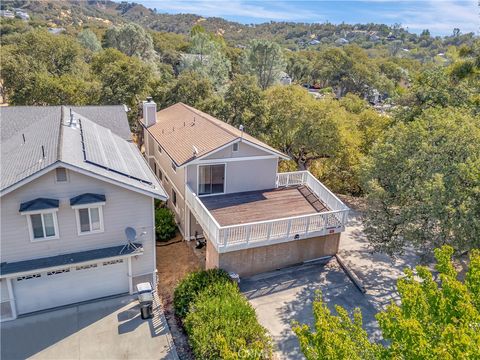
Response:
[141,99,349,276]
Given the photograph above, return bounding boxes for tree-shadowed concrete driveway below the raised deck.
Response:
[240,258,379,360]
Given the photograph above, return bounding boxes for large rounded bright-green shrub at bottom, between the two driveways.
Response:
[184,281,272,360]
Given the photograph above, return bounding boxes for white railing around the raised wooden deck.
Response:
[186,171,349,252]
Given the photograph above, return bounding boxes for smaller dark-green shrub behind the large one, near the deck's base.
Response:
[173,269,230,319]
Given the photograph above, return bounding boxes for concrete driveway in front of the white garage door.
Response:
[1,296,178,360]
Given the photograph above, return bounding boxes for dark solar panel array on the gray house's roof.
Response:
[80,118,151,184]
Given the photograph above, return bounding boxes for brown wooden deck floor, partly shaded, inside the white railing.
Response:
[200,186,328,226]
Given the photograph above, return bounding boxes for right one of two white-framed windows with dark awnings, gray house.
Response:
[70,193,106,235]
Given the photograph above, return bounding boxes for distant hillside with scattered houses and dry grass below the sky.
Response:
[1,0,474,57]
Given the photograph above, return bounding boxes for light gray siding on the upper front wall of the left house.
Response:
[0,171,155,276]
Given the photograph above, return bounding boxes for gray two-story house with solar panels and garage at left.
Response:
[0,106,167,320]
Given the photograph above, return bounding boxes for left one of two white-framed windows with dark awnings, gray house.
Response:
[20,198,59,241]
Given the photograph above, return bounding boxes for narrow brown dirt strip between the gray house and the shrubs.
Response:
[157,235,205,360]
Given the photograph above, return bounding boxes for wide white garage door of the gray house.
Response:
[12,259,129,314]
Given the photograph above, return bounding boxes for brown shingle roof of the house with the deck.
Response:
[148,103,286,166]
